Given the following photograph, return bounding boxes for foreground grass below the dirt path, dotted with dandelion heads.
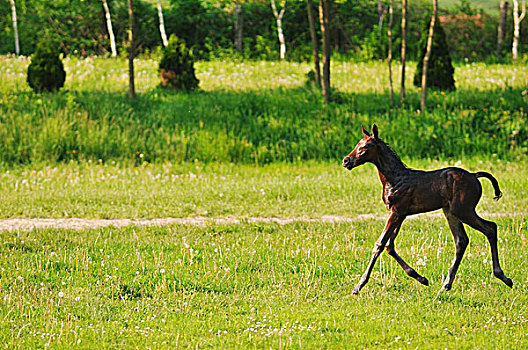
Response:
[0,218,528,349]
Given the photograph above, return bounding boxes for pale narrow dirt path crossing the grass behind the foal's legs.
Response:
[0,213,528,231]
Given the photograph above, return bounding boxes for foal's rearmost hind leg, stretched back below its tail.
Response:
[457,211,513,288]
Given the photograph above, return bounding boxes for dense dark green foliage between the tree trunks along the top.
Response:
[0,0,528,61]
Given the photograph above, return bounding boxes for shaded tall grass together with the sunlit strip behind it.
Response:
[0,57,528,164]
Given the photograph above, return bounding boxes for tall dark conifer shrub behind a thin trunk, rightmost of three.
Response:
[413,19,455,90]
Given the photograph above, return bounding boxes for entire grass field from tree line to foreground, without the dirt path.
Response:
[0,57,528,349]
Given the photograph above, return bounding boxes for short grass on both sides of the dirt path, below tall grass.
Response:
[0,160,528,349]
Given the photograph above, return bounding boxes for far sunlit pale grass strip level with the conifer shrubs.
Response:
[0,56,528,93]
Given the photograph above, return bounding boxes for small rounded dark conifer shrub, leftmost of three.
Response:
[27,41,66,92]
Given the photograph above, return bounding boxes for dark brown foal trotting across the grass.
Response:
[343,124,513,294]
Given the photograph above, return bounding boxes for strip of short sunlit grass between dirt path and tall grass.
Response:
[0,159,528,218]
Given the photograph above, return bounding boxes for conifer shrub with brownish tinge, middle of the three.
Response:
[159,35,199,90]
